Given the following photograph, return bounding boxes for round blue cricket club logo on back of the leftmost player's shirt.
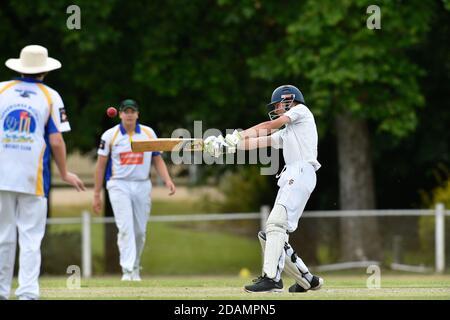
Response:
[2,109,36,150]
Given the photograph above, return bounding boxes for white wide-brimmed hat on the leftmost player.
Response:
[5,45,61,74]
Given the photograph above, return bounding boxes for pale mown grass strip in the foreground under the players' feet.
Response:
[9,273,450,300]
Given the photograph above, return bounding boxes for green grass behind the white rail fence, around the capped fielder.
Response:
[43,201,261,275]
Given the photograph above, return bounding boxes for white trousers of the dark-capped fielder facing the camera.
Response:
[106,179,152,272]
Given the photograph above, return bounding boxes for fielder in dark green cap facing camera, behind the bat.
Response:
[93,99,175,281]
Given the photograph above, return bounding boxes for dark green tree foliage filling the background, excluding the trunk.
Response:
[0,0,450,209]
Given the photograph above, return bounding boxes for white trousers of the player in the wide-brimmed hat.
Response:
[0,191,47,299]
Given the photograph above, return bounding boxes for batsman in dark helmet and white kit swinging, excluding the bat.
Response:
[205,85,323,292]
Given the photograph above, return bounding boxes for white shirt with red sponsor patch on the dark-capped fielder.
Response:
[97,123,161,181]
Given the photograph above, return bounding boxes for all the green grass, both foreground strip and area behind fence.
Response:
[38,201,450,300]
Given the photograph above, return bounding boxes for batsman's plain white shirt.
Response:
[271,104,321,171]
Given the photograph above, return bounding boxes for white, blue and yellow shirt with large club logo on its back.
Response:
[0,78,70,196]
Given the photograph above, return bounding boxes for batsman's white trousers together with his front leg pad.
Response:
[263,161,316,281]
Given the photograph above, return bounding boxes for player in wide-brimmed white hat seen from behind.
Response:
[0,45,84,300]
